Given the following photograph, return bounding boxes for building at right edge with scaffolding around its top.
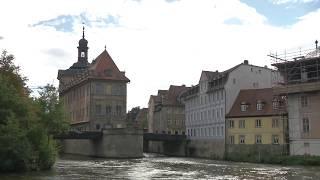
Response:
[273,48,320,156]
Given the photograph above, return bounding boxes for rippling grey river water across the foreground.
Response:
[0,154,320,180]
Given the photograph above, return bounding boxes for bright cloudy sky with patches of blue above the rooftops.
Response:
[0,0,320,109]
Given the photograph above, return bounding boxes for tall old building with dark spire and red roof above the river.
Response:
[58,27,130,131]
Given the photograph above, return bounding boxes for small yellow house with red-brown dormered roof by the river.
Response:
[226,88,288,162]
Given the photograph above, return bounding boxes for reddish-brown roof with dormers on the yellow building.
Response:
[226,88,282,118]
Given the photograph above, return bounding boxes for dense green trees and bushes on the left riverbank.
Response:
[0,51,68,172]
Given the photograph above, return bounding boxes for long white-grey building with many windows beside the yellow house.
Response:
[182,60,280,157]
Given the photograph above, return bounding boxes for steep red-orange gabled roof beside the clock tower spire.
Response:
[89,50,130,82]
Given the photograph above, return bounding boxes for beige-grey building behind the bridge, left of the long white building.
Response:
[148,85,188,135]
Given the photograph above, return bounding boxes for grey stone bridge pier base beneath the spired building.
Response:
[62,128,143,158]
